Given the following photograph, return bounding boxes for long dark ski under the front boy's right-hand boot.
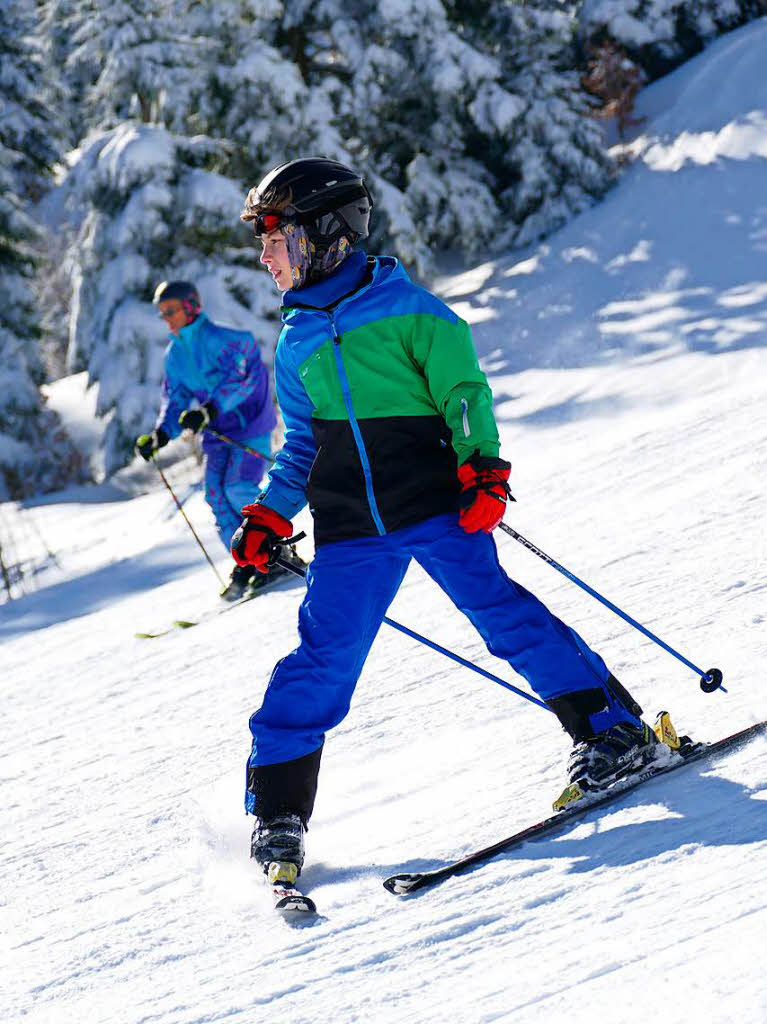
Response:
[383,721,767,896]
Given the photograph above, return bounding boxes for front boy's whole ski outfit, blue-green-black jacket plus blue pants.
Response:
[246,253,638,821]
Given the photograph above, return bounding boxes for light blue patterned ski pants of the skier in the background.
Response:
[203,434,271,551]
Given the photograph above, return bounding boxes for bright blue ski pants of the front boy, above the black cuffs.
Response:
[246,515,625,786]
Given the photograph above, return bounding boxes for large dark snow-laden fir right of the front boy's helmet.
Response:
[248,0,610,272]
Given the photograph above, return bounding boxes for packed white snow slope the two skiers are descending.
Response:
[0,20,767,1024]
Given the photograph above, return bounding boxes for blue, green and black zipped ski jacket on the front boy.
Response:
[260,252,499,544]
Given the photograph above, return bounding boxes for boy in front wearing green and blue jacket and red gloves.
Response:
[231,158,656,884]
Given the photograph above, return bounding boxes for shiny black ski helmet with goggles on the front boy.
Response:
[241,157,373,251]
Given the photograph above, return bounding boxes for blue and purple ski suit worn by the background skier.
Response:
[157,313,276,551]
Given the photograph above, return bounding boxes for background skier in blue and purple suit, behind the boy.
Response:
[135,281,292,600]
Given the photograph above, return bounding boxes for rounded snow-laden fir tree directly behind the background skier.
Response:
[59,123,275,473]
